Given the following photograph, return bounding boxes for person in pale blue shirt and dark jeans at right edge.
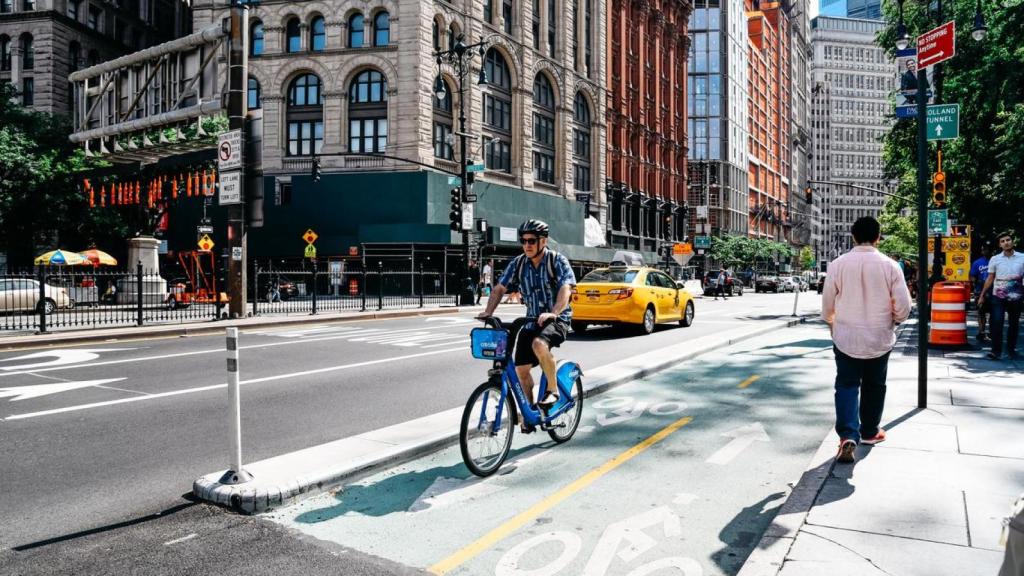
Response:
[978,233,1024,360]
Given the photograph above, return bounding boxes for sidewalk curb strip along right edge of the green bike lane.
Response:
[736,322,916,576]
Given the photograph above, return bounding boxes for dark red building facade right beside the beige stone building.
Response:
[602,0,693,251]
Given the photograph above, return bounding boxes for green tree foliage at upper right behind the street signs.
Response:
[878,0,1024,243]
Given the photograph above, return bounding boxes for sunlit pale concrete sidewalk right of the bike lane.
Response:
[739,319,1024,576]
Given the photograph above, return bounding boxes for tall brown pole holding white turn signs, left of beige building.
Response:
[227,3,249,318]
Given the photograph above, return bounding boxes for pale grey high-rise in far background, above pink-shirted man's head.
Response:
[811,16,896,261]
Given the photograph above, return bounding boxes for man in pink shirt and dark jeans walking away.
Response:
[821,216,910,463]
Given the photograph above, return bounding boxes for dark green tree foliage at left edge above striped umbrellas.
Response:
[0,84,127,266]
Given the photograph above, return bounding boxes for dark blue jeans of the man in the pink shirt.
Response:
[833,346,890,442]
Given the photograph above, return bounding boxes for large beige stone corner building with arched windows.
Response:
[194,0,605,260]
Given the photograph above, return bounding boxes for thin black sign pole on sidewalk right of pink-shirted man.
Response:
[916,67,930,408]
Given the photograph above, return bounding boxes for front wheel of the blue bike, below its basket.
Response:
[459,382,515,477]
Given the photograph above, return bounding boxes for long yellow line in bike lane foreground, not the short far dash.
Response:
[427,416,693,574]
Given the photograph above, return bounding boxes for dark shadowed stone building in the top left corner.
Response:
[0,0,191,114]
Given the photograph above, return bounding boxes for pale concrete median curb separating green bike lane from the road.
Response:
[193,315,816,512]
